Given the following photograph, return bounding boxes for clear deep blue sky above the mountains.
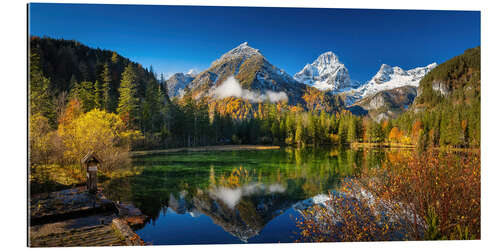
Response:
[29,3,481,81]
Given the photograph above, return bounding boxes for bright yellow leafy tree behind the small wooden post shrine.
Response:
[58,109,140,171]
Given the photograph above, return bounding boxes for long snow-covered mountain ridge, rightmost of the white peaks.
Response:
[346,63,437,104]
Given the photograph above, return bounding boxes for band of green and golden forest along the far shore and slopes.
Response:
[29,36,480,171]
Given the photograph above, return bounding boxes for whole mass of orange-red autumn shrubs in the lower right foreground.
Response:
[297,151,481,242]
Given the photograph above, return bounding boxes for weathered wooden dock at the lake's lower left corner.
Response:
[28,187,145,247]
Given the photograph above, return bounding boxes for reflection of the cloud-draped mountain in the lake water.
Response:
[156,183,305,242]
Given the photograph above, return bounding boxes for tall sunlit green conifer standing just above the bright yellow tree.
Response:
[117,64,139,127]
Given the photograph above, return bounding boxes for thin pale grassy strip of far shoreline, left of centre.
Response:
[129,145,281,157]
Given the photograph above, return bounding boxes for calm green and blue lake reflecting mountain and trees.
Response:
[104,148,387,245]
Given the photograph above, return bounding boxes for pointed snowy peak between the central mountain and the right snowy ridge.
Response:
[293,51,358,91]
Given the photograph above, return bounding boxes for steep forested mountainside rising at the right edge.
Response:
[395,47,481,148]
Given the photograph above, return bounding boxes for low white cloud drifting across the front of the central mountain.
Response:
[214,76,288,103]
